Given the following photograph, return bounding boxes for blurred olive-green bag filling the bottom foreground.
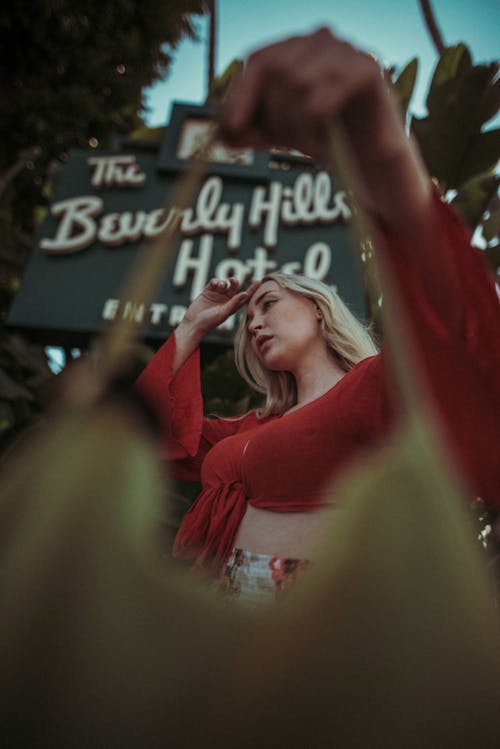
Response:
[0,380,500,748]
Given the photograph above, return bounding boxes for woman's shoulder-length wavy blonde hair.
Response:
[235,272,378,418]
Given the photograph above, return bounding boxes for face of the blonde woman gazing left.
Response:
[246,280,325,373]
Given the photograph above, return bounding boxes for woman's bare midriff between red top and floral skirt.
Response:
[234,505,334,561]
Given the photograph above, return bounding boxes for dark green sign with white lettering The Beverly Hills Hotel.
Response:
[9,104,364,345]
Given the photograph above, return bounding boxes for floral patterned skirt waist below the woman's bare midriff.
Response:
[217,549,311,607]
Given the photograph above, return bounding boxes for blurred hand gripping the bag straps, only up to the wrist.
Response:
[221,28,390,161]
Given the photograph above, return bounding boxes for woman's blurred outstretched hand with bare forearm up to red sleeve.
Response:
[220,28,430,226]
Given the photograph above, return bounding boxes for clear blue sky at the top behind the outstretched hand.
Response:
[145,0,500,126]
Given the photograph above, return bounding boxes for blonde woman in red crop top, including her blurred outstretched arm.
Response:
[139,29,500,596]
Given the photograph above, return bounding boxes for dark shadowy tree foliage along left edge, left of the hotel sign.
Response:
[0,0,206,444]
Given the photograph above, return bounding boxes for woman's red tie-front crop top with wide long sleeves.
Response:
[138,190,500,568]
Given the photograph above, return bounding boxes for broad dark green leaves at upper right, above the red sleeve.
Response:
[395,43,500,272]
